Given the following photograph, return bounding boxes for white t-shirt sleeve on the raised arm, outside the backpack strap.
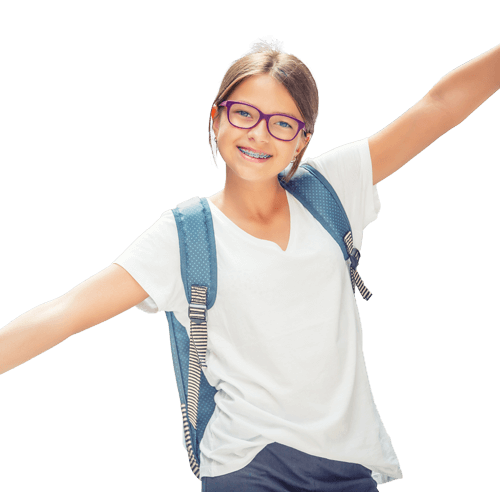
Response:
[303,138,381,249]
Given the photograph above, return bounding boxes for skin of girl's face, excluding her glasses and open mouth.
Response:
[213,74,310,182]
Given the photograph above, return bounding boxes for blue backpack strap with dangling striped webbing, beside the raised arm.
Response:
[279,164,373,301]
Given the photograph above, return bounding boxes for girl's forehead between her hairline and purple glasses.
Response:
[229,74,301,119]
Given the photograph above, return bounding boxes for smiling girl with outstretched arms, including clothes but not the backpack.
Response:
[0,36,500,492]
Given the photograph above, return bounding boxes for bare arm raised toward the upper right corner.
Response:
[368,44,500,184]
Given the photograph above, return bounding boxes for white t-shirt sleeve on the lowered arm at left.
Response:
[113,210,185,314]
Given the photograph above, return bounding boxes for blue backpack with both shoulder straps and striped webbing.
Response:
[165,164,372,480]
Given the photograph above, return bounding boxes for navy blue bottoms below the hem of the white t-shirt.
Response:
[201,442,378,492]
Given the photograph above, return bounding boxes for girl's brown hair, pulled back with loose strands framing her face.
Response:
[208,39,319,183]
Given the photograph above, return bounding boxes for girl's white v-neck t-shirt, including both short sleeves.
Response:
[115,138,403,485]
